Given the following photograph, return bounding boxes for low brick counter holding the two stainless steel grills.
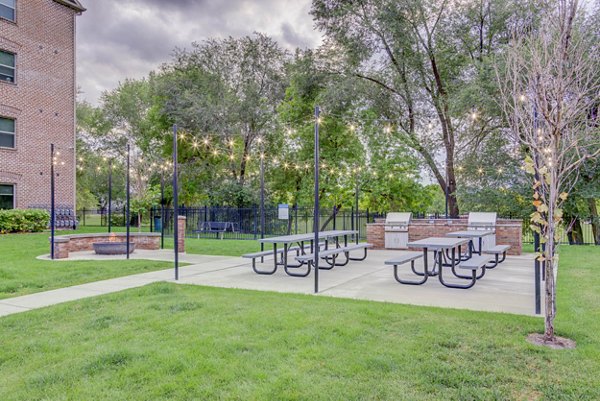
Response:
[367,219,523,255]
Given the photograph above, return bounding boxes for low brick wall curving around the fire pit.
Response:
[54,233,160,259]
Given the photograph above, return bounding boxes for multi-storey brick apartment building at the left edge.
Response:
[0,0,85,209]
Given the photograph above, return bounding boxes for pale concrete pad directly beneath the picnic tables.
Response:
[179,250,535,315]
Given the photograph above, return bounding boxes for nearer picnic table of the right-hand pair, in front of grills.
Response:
[406,237,485,288]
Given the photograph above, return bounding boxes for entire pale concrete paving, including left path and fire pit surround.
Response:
[0,250,534,316]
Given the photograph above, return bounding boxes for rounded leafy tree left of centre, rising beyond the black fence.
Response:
[153,33,288,206]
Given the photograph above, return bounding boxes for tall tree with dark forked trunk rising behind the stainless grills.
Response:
[311,0,536,217]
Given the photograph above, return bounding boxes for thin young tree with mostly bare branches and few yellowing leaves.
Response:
[497,0,600,346]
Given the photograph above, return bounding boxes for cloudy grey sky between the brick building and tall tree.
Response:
[77,0,321,103]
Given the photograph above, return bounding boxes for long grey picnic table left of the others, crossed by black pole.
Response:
[253,230,358,277]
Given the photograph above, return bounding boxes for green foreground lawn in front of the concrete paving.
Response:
[0,247,600,401]
